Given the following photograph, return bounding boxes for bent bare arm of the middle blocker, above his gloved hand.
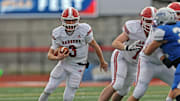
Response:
[112,32,129,50]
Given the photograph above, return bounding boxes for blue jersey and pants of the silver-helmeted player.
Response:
[154,22,180,89]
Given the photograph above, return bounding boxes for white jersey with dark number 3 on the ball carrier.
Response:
[51,23,93,64]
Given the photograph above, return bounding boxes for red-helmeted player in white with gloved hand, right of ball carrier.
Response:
[99,7,156,101]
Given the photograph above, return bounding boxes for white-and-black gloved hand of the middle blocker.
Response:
[124,40,143,51]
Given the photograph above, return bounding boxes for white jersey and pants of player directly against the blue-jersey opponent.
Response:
[133,28,175,99]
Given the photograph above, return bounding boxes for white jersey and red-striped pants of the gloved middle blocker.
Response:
[111,20,146,96]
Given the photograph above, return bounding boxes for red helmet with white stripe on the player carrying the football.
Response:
[61,7,80,32]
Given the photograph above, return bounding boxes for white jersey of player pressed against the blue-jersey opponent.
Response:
[140,27,163,64]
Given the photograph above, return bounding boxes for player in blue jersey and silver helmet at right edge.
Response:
[144,8,180,101]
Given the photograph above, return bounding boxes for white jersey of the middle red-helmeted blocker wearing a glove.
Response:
[119,20,146,63]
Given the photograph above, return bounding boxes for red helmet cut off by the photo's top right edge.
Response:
[167,2,180,20]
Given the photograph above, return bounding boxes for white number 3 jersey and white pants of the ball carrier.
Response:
[40,23,93,101]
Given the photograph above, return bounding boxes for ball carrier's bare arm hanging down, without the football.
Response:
[89,39,108,72]
